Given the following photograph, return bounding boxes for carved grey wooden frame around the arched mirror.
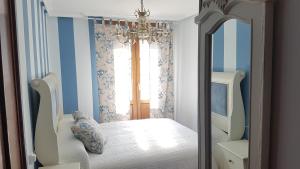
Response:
[195,0,273,169]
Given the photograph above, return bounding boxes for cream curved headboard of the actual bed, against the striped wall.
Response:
[31,73,63,165]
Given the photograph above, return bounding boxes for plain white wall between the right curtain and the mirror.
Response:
[174,16,198,131]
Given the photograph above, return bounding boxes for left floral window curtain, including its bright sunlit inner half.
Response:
[95,23,131,122]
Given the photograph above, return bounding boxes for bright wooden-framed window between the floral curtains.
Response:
[114,41,160,119]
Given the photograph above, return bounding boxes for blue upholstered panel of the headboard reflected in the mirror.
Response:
[211,83,227,116]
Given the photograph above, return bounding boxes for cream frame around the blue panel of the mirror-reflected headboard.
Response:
[211,71,245,140]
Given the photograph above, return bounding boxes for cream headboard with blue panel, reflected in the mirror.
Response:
[211,71,245,140]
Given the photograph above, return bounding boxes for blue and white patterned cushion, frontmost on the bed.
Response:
[71,120,104,154]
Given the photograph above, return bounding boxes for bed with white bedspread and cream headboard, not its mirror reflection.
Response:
[32,73,198,169]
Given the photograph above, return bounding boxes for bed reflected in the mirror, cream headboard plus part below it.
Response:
[211,71,245,169]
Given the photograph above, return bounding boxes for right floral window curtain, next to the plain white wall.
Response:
[149,36,174,119]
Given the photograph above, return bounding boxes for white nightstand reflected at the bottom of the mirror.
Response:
[218,140,249,169]
